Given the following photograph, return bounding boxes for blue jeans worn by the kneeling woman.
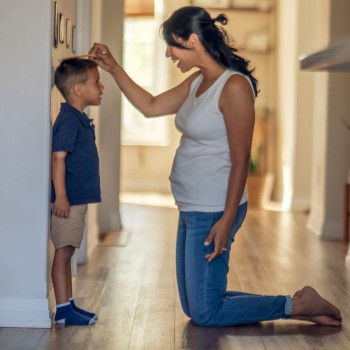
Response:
[176,203,291,327]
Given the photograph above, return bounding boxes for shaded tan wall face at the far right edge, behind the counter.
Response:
[321,0,350,239]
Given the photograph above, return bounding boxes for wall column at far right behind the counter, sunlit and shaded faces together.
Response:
[304,0,350,239]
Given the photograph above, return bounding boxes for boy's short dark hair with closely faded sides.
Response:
[55,58,97,99]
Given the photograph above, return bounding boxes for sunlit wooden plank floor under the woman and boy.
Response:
[0,204,350,350]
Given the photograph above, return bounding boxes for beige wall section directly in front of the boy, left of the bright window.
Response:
[89,0,124,233]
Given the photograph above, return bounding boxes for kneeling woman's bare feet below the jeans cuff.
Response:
[291,287,342,327]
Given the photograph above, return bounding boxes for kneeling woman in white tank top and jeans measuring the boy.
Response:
[91,6,341,326]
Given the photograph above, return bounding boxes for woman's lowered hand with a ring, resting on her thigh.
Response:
[204,219,231,262]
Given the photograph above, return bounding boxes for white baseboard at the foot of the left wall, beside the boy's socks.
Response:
[0,298,51,328]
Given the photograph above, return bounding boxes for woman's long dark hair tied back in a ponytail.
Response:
[162,6,259,95]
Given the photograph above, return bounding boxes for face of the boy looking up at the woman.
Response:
[80,68,104,106]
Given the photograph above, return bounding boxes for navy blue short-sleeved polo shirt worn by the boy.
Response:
[51,103,101,205]
